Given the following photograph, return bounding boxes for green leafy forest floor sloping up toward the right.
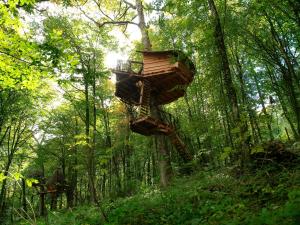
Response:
[24,156,300,225]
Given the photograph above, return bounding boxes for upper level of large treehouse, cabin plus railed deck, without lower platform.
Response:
[113,51,195,105]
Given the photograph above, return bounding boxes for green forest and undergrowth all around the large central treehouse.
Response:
[0,0,300,225]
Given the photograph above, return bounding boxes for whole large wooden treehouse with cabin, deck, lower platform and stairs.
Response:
[113,51,195,162]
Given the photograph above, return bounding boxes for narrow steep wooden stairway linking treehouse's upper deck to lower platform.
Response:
[139,80,151,117]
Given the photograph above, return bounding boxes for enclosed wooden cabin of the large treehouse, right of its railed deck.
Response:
[142,51,195,105]
